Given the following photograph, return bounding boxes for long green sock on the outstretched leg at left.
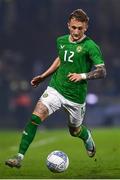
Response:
[19,114,42,155]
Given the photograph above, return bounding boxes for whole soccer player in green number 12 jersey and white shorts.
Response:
[5,9,106,168]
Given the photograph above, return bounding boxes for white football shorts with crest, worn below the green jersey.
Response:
[40,86,85,127]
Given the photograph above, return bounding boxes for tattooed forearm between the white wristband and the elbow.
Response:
[87,65,106,79]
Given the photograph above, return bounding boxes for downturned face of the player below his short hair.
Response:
[68,18,87,41]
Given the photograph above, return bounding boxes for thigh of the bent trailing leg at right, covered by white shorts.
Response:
[66,103,86,127]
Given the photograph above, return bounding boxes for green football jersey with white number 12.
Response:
[49,35,104,104]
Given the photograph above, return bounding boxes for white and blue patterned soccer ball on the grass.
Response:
[46,150,69,173]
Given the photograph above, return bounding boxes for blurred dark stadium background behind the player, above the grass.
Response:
[0,0,120,129]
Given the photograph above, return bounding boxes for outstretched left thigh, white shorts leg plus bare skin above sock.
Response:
[35,87,61,119]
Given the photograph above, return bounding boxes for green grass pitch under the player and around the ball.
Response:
[0,128,120,179]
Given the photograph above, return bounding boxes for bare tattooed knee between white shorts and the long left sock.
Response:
[33,101,49,121]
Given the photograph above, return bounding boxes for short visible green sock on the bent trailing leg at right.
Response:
[77,125,89,141]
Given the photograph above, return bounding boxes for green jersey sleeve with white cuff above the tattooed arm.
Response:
[89,44,104,65]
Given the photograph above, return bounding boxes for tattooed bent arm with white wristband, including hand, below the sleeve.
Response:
[68,65,106,82]
